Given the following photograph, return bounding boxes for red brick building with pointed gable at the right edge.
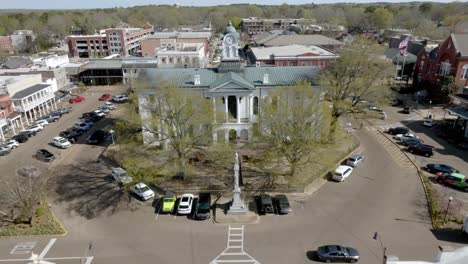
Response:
[413,33,468,87]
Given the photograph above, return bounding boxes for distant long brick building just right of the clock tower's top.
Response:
[241,17,307,35]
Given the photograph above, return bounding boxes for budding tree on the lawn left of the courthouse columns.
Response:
[137,80,214,178]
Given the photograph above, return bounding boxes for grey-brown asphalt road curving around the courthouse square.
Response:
[0,89,461,264]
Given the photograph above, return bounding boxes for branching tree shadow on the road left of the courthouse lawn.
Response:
[51,163,132,219]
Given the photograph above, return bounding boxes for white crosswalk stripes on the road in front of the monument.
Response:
[210,225,260,264]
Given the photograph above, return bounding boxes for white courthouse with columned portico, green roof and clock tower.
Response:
[138,23,320,144]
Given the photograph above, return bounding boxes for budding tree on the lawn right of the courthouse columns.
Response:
[261,82,322,175]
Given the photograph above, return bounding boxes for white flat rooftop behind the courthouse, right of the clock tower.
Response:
[251,45,335,60]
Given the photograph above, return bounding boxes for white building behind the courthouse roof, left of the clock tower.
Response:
[156,43,208,68]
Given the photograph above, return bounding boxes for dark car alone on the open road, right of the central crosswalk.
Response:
[317,245,359,263]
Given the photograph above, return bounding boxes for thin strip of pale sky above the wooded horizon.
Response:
[0,0,458,9]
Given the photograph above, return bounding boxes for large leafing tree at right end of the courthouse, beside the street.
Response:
[320,38,391,141]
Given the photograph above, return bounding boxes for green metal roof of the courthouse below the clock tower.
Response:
[139,66,320,88]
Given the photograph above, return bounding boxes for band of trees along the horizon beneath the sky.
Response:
[0,2,468,51]
